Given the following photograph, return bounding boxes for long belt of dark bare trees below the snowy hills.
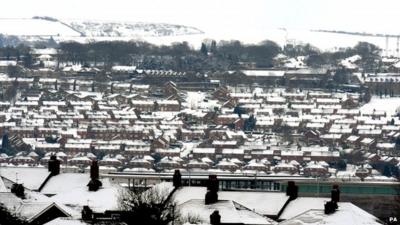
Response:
[0,40,382,72]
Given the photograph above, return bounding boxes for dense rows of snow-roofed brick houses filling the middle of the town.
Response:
[0,74,400,178]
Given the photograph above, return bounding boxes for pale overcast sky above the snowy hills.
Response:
[0,0,400,36]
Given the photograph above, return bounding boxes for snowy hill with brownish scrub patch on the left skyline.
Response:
[0,17,203,39]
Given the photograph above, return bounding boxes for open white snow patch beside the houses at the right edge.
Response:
[360,96,400,116]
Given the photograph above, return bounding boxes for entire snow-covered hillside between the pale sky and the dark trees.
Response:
[0,18,396,52]
